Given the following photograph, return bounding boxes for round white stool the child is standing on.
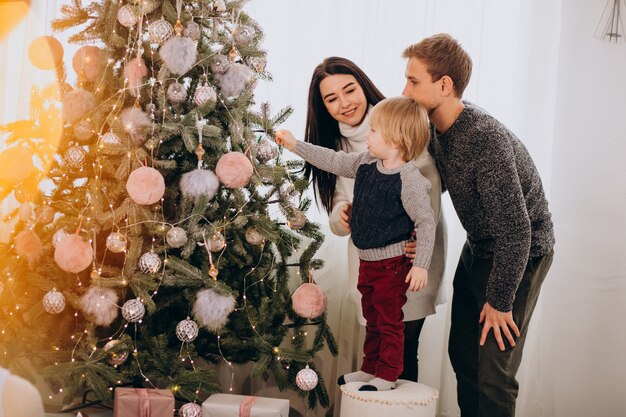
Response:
[341,379,439,417]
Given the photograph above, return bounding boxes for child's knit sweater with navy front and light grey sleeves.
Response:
[294,142,436,269]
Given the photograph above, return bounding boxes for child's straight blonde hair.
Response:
[371,97,429,161]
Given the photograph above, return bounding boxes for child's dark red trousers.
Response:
[357,255,413,381]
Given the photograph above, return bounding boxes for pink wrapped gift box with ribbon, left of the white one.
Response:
[113,387,174,417]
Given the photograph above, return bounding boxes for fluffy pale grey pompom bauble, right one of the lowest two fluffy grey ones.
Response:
[193,288,236,332]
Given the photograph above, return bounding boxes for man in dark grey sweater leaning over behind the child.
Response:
[403,34,554,417]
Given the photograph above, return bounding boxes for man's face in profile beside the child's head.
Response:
[402,58,443,115]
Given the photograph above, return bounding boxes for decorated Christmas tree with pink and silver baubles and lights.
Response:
[0,0,336,407]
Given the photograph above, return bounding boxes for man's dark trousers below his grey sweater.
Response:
[448,243,553,417]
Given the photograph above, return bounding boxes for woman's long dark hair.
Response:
[304,56,385,213]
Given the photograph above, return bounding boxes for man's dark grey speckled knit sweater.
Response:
[430,102,554,311]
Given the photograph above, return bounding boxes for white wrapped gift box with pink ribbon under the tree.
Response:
[202,394,289,417]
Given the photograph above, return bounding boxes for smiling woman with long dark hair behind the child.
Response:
[304,57,445,381]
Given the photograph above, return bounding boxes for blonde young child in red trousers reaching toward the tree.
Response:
[276,97,436,391]
